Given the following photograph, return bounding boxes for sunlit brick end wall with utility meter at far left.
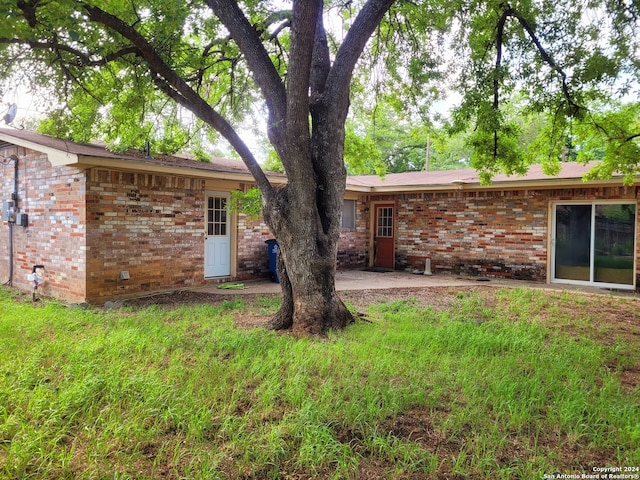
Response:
[0,147,86,302]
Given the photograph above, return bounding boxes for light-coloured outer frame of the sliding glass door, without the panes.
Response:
[549,200,638,290]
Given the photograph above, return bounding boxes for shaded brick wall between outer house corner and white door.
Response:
[87,168,206,302]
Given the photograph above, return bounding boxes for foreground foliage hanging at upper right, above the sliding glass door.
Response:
[454,1,640,183]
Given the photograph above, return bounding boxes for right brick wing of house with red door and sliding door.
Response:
[348,163,640,289]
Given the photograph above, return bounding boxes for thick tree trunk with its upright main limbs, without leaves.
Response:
[232,0,394,336]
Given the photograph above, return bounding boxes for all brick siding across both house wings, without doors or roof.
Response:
[0,142,640,303]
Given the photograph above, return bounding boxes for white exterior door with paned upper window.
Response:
[204,194,231,277]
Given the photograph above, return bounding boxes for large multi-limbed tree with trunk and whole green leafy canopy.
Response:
[0,0,640,335]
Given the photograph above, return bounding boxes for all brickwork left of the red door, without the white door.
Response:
[0,149,366,303]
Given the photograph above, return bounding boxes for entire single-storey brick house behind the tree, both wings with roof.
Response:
[0,129,640,303]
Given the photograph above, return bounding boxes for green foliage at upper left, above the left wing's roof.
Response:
[0,0,253,153]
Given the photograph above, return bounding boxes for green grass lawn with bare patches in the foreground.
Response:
[0,288,640,479]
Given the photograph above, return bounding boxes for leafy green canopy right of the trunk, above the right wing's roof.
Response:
[346,1,640,184]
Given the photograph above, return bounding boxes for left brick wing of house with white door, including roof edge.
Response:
[0,129,284,303]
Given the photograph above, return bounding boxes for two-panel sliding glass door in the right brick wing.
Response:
[552,202,636,288]
